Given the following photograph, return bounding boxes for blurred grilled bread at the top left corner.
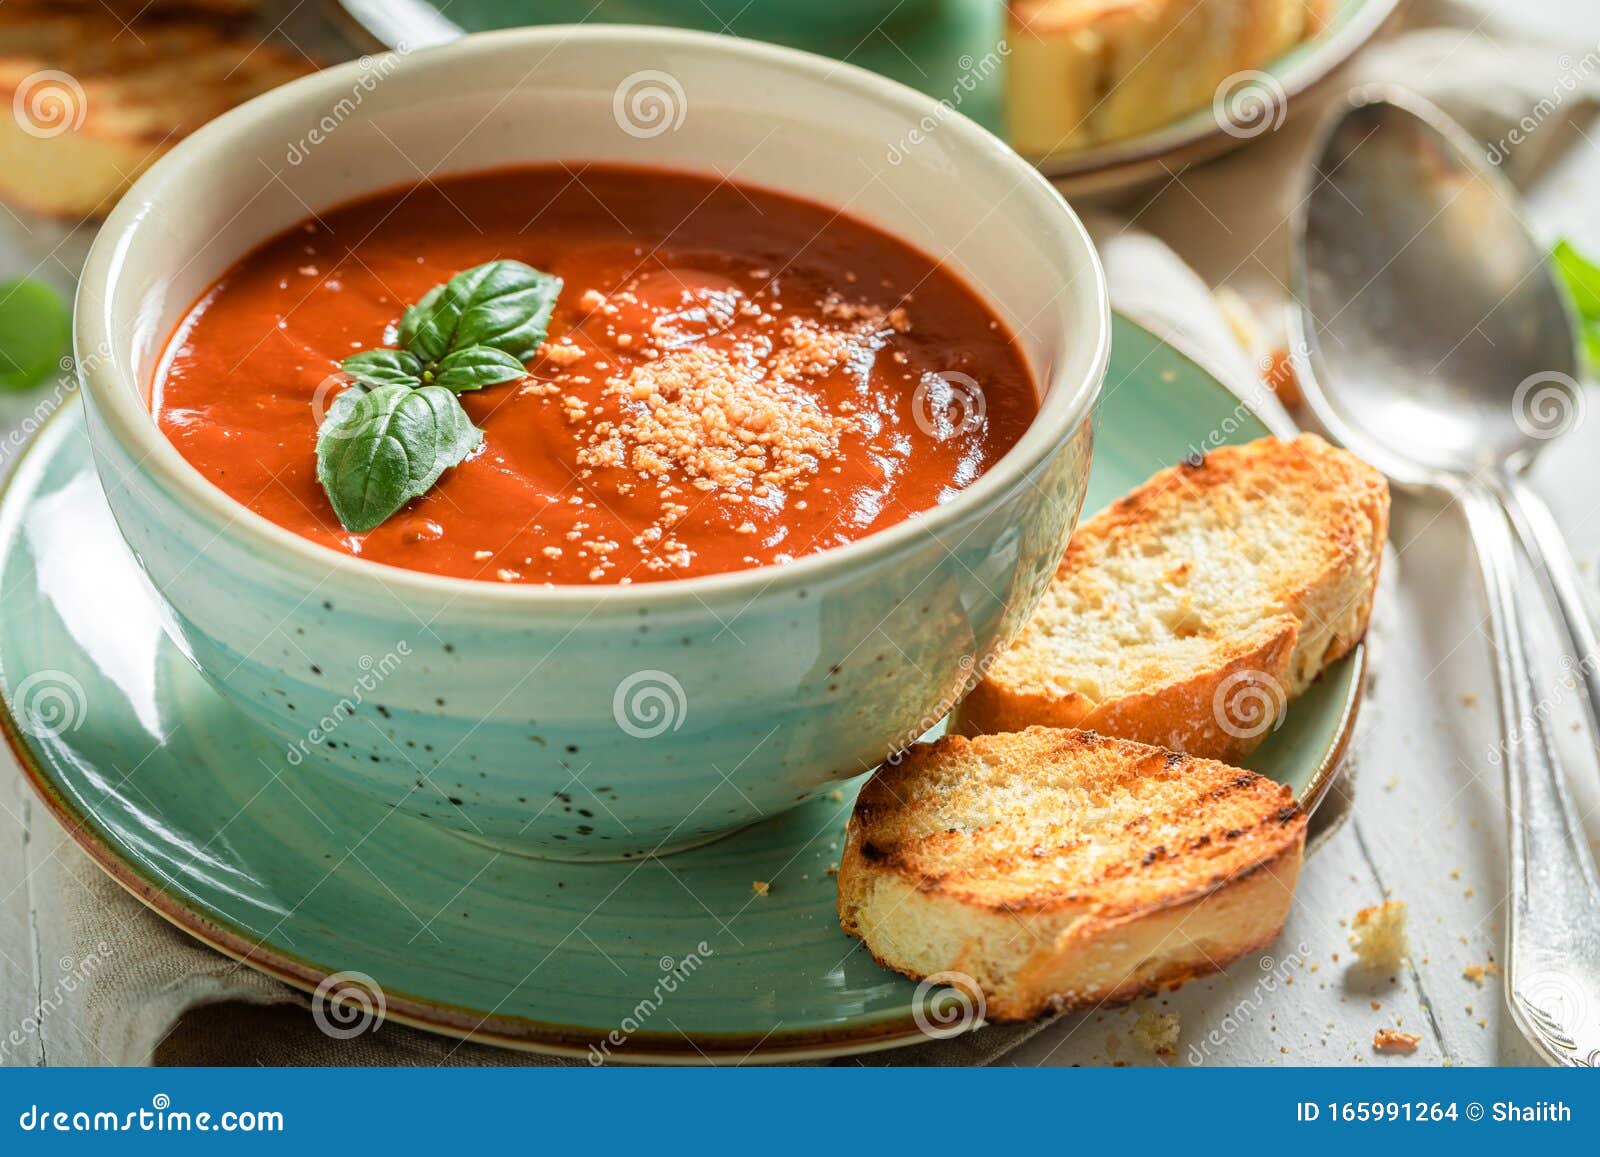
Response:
[0,5,314,218]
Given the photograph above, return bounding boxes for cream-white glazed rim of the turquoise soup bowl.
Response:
[74,24,1110,610]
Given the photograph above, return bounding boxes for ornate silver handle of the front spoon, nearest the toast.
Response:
[1458,483,1600,1066]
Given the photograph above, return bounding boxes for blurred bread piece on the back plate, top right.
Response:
[1005,0,1331,157]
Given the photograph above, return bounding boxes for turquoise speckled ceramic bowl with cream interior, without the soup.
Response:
[75,27,1109,858]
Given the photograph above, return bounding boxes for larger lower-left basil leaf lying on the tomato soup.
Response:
[317,384,483,533]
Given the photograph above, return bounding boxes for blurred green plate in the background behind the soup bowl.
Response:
[339,0,1398,192]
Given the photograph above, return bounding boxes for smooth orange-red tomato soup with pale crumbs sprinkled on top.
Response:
[152,165,1037,584]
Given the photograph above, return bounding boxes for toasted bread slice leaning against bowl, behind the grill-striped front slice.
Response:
[957,434,1389,762]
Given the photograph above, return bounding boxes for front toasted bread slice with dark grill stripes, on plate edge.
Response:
[838,727,1306,1021]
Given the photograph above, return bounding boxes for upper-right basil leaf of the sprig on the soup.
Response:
[400,261,562,362]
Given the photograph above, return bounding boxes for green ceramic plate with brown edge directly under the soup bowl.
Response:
[0,318,1360,1061]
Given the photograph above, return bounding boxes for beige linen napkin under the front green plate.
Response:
[9,0,1600,1066]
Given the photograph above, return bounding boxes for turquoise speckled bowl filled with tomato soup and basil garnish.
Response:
[75,27,1109,859]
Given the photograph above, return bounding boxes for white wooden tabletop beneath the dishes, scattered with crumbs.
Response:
[0,2,1600,1066]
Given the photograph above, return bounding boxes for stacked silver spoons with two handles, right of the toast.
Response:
[1291,88,1600,1066]
